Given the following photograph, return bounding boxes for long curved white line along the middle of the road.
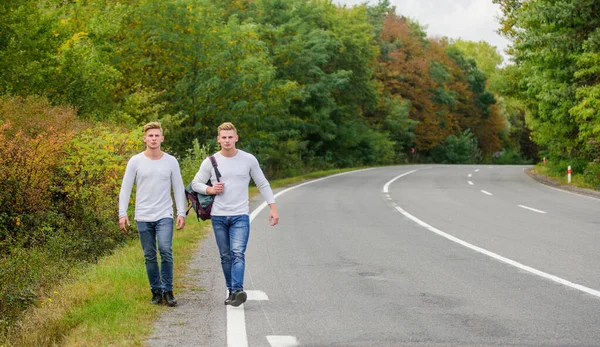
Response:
[383,170,600,298]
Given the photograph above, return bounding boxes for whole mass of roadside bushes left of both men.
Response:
[0,97,142,336]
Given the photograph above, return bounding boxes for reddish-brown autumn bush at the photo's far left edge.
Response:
[0,97,78,253]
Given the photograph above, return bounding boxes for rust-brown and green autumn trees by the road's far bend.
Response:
[376,14,506,153]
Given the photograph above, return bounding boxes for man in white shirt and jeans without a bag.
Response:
[119,122,186,306]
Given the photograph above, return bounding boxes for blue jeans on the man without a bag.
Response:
[136,218,173,293]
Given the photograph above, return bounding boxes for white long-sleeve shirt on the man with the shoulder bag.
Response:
[192,149,275,216]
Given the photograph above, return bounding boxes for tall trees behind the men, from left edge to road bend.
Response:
[0,0,534,173]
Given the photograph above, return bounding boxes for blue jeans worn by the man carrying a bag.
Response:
[210,214,250,291]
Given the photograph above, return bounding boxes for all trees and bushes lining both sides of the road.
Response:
[0,0,600,338]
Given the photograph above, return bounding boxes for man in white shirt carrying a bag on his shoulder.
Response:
[192,122,279,306]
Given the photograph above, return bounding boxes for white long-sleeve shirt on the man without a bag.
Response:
[119,152,186,222]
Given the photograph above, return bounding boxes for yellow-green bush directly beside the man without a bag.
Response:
[53,125,142,247]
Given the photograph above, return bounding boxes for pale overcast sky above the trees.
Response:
[333,0,509,60]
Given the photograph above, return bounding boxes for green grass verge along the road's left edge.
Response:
[0,169,354,347]
